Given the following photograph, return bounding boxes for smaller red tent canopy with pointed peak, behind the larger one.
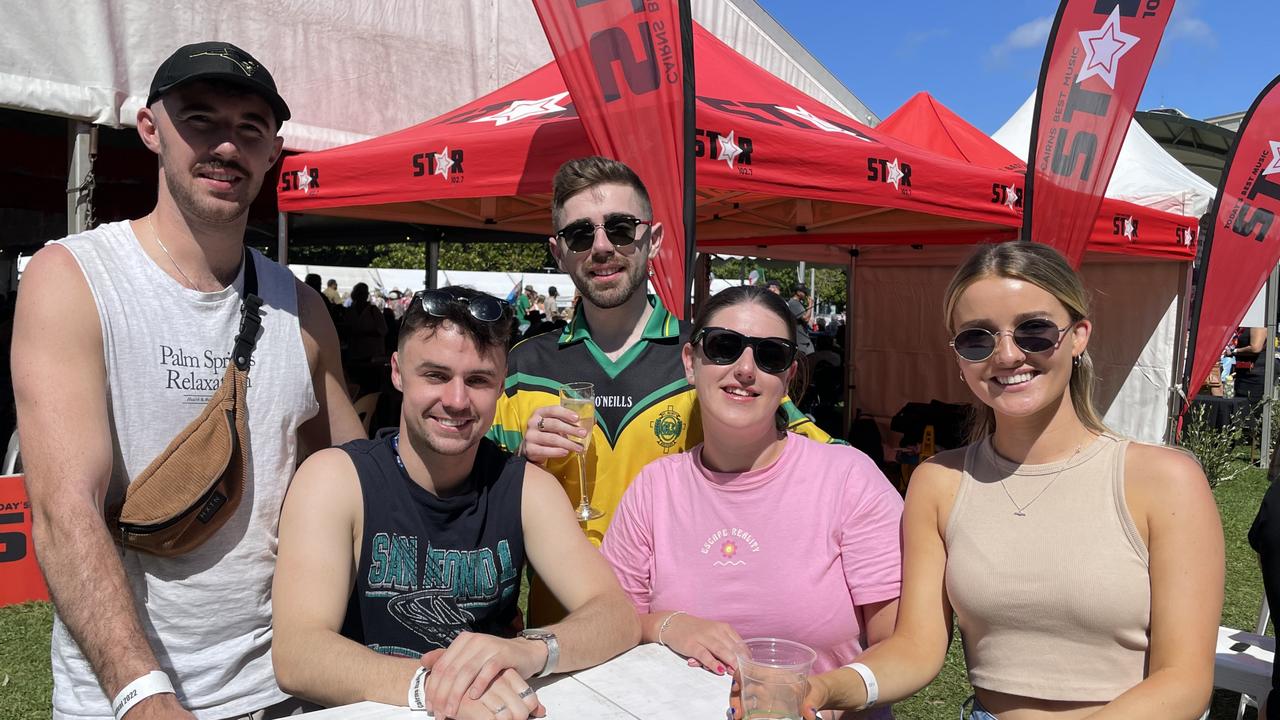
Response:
[876,92,1198,260]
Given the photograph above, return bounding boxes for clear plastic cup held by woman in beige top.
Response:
[737,638,818,720]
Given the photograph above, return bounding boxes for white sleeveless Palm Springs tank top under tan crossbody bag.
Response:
[52,223,319,720]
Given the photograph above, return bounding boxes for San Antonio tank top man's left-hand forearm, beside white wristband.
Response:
[271,628,421,707]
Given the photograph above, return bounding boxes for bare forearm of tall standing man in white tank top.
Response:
[32,501,160,700]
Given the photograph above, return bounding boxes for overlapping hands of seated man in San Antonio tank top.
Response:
[422,633,547,720]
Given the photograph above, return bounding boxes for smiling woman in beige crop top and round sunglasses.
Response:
[778,242,1224,720]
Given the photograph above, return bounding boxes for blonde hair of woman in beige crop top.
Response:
[942,241,1111,442]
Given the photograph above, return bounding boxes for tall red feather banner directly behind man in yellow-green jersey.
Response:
[534,0,694,316]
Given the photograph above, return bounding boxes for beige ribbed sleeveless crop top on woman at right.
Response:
[946,436,1151,702]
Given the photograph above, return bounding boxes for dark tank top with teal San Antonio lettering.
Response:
[342,433,525,659]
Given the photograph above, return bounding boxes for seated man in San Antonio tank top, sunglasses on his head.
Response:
[273,287,640,720]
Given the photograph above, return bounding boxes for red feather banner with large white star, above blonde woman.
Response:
[1023,0,1174,266]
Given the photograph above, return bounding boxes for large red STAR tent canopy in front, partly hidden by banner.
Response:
[279,27,1021,249]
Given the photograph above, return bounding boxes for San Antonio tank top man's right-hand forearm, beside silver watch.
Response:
[548,593,640,673]
